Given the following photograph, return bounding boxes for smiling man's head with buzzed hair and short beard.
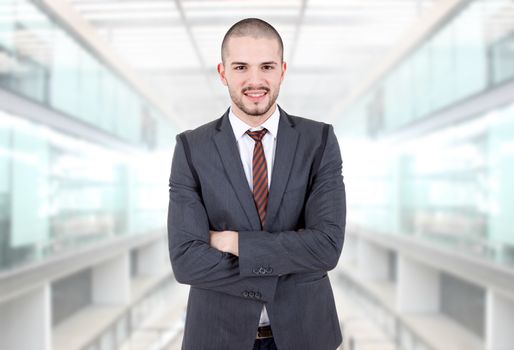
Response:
[218,18,286,124]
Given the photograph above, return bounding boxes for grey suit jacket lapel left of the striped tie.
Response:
[214,110,261,230]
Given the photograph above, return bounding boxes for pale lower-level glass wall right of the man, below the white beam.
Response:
[340,103,514,267]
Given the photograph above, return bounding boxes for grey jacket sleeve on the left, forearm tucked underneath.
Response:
[168,136,277,302]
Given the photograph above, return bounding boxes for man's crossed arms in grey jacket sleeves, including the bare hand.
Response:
[168,127,346,301]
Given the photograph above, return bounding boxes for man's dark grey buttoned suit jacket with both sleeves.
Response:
[168,107,346,350]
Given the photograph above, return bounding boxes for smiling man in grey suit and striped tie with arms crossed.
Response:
[168,18,346,350]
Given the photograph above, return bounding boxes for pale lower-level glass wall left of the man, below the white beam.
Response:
[0,112,171,271]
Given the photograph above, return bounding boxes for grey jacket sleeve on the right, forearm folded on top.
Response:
[239,126,346,276]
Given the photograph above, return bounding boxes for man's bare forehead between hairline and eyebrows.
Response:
[226,36,281,63]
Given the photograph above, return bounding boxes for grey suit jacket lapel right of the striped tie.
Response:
[264,105,298,230]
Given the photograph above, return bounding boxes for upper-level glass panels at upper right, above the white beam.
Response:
[341,0,514,137]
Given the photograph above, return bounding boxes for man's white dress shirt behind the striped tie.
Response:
[228,105,280,326]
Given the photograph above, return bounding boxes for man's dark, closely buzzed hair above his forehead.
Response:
[221,18,284,64]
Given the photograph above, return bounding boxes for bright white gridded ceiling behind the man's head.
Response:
[68,0,437,129]
